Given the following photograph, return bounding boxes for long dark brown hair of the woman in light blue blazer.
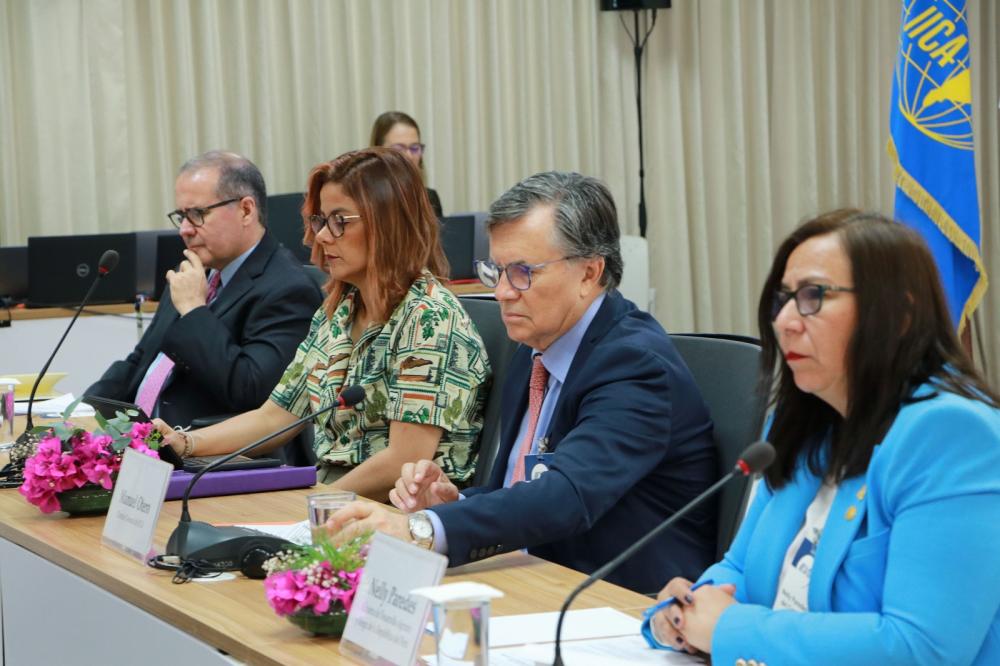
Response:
[757,209,1000,488]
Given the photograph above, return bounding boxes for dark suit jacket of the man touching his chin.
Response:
[86,233,322,425]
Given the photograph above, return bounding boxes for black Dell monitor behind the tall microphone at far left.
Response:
[28,233,136,307]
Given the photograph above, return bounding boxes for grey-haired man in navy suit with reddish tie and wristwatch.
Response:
[330,173,717,592]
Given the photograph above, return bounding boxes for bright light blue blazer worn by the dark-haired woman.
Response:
[702,385,1000,666]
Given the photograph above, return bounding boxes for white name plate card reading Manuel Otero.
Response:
[101,449,174,564]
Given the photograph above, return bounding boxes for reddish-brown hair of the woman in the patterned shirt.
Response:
[302,148,448,317]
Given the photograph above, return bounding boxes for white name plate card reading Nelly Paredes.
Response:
[340,532,448,666]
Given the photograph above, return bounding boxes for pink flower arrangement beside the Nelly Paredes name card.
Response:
[264,534,371,636]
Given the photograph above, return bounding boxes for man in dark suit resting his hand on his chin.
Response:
[86,151,322,426]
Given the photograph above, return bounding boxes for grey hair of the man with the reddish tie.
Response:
[486,171,624,291]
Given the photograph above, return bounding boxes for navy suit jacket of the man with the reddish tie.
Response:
[433,292,718,593]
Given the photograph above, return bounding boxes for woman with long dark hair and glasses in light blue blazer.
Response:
[653,211,1000,666]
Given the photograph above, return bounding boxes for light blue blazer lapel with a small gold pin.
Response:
[809,475,868,612]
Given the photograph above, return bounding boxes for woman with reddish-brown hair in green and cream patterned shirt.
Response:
[158,148,490,499]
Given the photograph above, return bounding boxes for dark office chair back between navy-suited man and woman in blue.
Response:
[670,333,765,561]
